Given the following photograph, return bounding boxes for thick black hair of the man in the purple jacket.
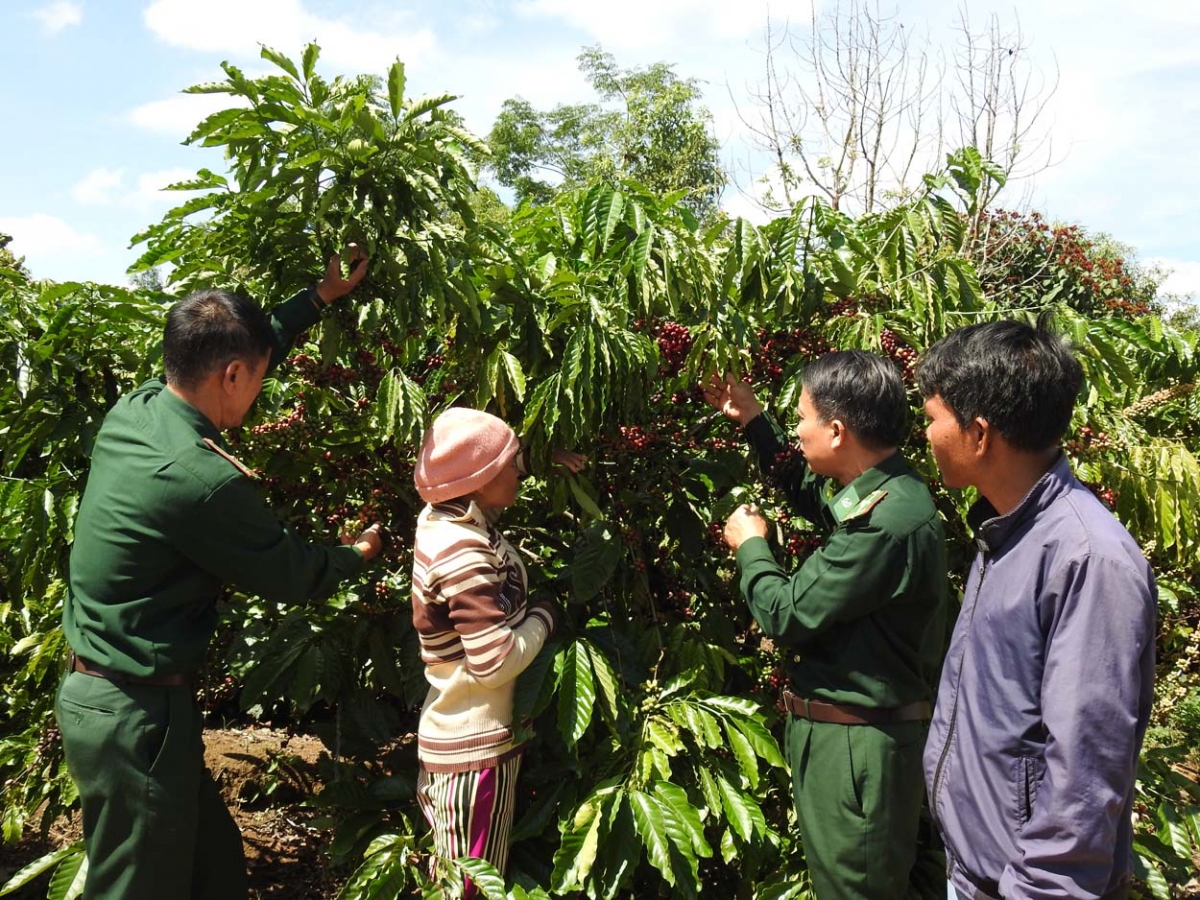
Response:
[917,316,1084,452]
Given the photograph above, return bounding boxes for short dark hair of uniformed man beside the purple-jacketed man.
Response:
[804,350,908,450]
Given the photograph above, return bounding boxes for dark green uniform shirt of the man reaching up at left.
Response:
[62,290,362,678]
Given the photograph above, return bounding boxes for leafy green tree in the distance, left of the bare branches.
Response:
[487,46,725,215]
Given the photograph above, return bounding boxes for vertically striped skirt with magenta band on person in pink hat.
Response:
[416,754,521,900]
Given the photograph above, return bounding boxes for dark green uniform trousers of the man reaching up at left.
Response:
[56,672,247,900]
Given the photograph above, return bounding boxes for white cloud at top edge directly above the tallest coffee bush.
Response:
[143,0,437,73]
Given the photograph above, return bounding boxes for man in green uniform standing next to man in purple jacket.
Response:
[707,350,948,900]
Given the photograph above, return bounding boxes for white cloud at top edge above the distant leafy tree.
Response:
[517,0,812,49]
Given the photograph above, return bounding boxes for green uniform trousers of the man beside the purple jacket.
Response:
[786,716,926,900]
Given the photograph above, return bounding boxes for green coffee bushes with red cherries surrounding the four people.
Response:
[7,46,1200,900]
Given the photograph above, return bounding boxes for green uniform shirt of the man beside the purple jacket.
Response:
[737,414,949,708]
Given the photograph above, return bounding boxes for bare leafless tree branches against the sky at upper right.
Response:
[734,0,1055,218]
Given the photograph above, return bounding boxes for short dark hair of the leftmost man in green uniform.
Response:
[162,290,275,388]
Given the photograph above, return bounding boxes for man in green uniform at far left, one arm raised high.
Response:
[56,250,380,900]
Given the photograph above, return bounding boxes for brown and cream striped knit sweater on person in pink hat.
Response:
[413,499,554,772]
